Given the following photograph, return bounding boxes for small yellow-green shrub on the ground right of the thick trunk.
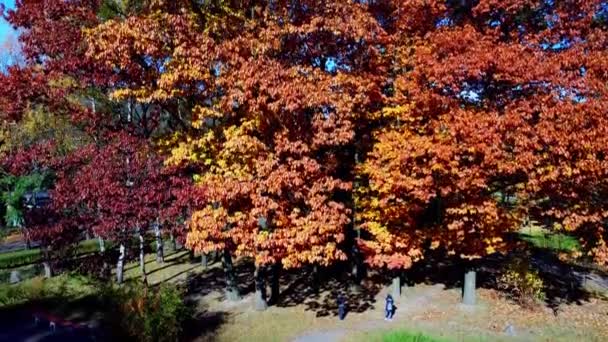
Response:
[498,256,545,307]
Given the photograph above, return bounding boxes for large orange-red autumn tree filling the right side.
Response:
[360,0,605,303]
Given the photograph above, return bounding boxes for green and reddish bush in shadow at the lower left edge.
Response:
[103,283,190,342]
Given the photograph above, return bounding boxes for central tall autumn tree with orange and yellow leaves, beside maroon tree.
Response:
[83,1,386,308]
